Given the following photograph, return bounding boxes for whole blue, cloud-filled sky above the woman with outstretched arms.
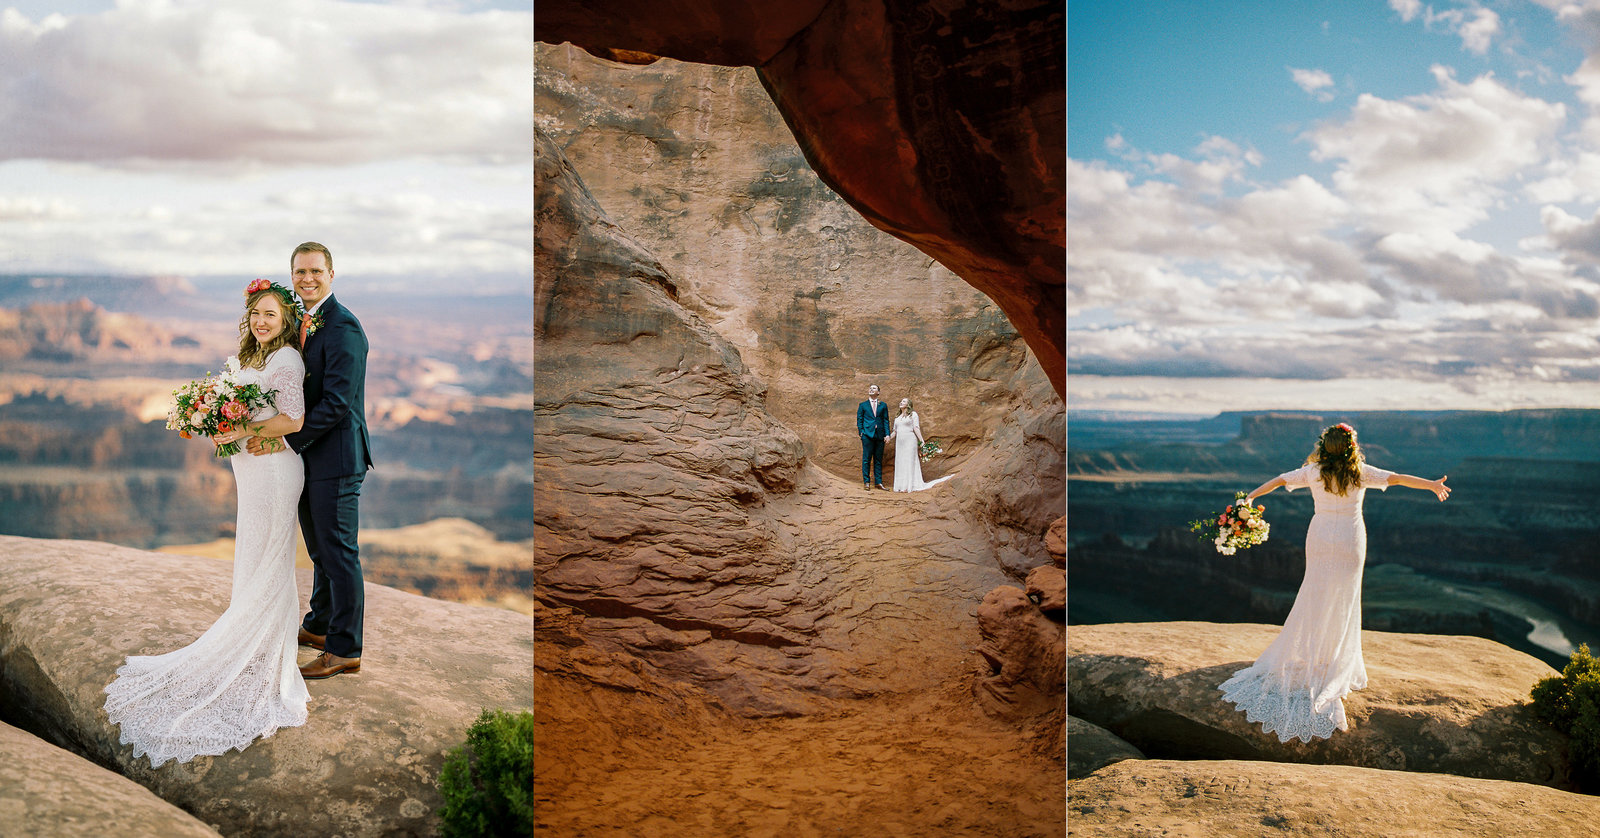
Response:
[1067,0,1600,413]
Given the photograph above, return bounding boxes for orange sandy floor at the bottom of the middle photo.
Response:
[534,672,1066,838]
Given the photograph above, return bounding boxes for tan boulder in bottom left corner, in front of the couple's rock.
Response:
[0,723,218,838]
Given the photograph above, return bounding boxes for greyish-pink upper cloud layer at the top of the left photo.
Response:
[0,0,533,165]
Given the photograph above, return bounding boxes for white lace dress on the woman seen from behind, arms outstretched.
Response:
[1218,464,1394,742]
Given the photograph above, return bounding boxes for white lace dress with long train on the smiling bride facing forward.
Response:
[106,347,310,768]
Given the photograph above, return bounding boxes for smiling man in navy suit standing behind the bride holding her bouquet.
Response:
[250,241,373,681]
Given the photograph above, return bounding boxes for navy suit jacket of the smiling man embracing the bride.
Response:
[285,297,373,480]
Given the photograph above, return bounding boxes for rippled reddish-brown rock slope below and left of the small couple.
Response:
[534,127,1061,715]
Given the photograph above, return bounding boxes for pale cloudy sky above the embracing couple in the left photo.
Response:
[0,0,533,293]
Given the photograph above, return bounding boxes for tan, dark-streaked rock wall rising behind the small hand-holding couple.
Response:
[534,45,1059,480]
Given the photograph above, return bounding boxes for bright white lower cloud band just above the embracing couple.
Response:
[0,163,533,281]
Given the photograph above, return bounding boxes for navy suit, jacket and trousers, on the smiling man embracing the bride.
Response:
[285,296,373,657]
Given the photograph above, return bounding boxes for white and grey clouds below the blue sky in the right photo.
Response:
[1067,0,1600,403]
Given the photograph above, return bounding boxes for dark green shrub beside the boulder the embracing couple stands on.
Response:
[438,710,533,838]
